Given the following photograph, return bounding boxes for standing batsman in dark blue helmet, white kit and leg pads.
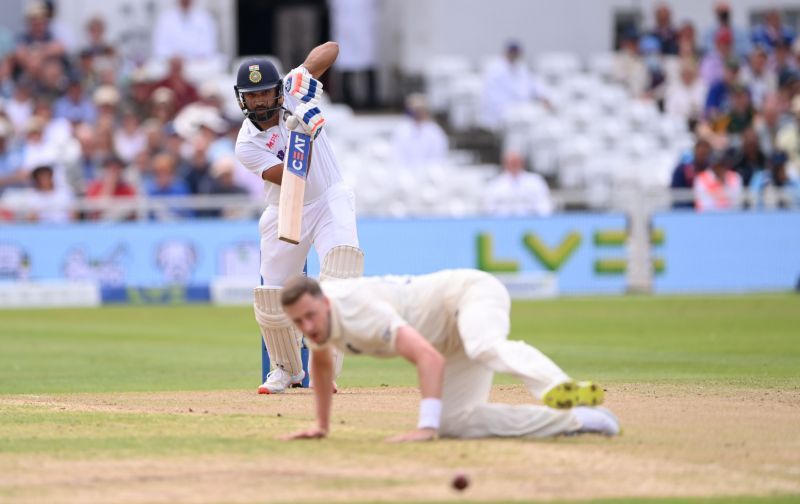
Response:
[234,42,364,394]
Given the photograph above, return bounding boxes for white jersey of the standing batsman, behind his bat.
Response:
[236,95,342,205]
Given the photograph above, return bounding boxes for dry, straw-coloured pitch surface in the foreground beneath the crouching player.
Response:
[0,384,800,503]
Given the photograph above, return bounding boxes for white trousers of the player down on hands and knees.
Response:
[439,275,580,438]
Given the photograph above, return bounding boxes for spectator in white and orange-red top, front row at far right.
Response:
[694,149,742,212]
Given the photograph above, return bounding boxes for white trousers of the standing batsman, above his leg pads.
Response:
[258,183,358,288]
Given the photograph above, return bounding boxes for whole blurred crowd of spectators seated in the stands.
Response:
[0,0,800,222]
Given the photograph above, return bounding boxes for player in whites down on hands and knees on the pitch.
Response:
[281,269,620,441]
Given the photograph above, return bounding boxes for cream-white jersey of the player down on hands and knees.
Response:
[314,270,489,357]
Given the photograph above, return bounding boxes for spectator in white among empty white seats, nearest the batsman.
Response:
[392,94,447,168]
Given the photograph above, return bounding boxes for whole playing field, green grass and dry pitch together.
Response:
[0,294,800,503]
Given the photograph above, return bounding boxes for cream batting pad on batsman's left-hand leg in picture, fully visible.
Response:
[253,287,303,375]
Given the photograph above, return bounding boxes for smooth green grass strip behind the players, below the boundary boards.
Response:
[0,294,800,394]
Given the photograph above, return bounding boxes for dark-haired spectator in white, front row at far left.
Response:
[13,166,75,224]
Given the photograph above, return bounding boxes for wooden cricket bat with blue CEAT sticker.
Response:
[278,131,311,245]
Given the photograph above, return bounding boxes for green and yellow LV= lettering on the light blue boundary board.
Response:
[476,229,665,275]
